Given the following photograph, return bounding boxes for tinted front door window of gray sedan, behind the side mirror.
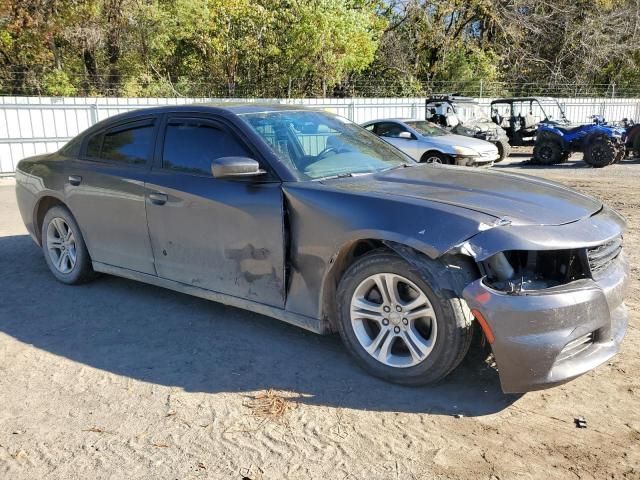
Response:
[162,119,249,176]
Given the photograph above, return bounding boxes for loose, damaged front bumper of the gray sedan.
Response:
[463,255,629,393]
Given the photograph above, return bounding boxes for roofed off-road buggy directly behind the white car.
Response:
[425,95,511,163]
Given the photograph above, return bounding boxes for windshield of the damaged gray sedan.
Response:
[239,110,415,180]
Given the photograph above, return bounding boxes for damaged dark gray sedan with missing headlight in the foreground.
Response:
[16,104,629,392]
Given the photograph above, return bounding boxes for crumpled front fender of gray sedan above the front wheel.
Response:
[283,182,496,318]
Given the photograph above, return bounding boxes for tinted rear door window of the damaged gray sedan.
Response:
[87,121,153,164]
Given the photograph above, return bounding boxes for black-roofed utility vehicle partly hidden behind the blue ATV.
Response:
[491,97,569,147]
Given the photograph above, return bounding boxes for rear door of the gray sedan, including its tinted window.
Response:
[65,116,159,274]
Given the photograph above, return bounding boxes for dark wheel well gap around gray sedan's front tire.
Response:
[322,239,386,331]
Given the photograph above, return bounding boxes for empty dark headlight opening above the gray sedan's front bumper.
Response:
[480,250,588,295]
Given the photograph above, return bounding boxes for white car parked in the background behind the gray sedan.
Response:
[362,119,500,167]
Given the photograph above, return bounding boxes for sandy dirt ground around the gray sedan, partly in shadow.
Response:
[0,153,640,480]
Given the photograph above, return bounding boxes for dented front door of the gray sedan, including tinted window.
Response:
[147,116,284,307]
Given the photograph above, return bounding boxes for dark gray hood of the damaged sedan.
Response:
[334,165,602,225]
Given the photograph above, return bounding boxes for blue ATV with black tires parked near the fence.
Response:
[533,115,626,168]
